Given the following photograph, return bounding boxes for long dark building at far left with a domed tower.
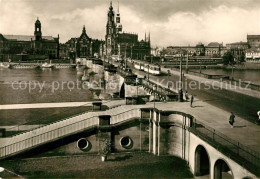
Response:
[0,18,59,61]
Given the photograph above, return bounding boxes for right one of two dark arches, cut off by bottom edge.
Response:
[214,158,234,179]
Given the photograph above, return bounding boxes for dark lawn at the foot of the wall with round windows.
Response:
[0,153,193,178]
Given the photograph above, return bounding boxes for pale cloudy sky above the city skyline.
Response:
[0,0,260,47]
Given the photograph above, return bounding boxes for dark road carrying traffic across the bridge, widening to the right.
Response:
[128,63,260,123]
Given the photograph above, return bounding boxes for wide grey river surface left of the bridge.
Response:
[0,69,94,104]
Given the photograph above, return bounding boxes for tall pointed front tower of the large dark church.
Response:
[106,1,116,55]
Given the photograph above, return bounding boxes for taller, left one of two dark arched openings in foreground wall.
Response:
[195,144,210,176]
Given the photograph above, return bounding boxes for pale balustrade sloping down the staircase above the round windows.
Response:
[0,109,141,158]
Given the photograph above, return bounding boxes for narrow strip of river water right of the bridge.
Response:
[192,69,260,85]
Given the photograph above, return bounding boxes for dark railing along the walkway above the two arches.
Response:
[190,120,260,174]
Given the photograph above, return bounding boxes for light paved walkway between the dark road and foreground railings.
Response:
[0,99,260,152]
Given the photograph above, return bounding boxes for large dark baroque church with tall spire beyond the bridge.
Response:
[104,2,151,59]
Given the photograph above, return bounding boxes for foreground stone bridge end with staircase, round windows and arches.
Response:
[0,104,260,179]
